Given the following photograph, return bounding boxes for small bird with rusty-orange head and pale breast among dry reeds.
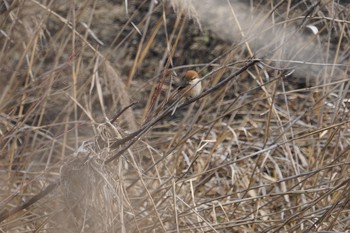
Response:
[178,70,202,98]
